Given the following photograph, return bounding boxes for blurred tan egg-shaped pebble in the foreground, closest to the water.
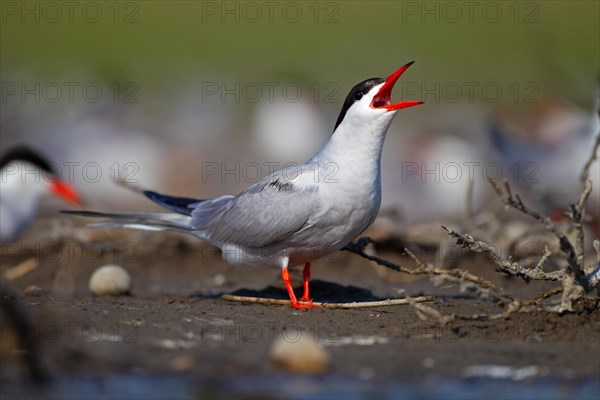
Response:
[271,332,330,374]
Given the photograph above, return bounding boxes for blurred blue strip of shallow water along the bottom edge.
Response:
[0,375,600,400]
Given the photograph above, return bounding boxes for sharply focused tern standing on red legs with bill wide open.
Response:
[64,62,422,309]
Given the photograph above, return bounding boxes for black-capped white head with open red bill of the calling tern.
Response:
[334,62,423,135]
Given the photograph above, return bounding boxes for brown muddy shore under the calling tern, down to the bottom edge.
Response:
[0,220,600,398]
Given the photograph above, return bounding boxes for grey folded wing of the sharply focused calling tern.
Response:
[191,176,319,248]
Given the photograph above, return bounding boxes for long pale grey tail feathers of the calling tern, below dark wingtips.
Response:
[61,211,193,234]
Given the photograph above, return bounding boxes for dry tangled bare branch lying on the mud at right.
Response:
[343,135,600,316]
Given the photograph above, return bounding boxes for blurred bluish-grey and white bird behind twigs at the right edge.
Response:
[488,99,600,218]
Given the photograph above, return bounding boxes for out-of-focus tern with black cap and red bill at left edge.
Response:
[0,146,81,243]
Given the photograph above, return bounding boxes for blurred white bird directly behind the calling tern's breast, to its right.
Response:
[384,132,488,224]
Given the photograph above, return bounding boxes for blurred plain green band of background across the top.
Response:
[1,0,600,102]
